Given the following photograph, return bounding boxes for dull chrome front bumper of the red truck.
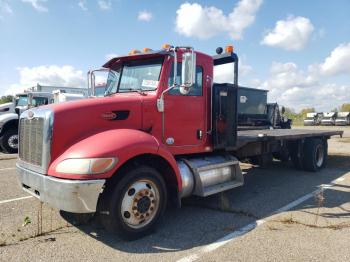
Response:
[16,164,106,213]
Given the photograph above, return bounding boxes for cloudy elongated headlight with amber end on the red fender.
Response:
[56,157,118,175]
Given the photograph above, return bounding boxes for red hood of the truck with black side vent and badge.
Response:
[45,93,143,160]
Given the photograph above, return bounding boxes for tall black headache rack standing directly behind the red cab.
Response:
[212,53,238,151]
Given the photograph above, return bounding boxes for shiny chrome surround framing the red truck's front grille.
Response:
[18,108,54,174]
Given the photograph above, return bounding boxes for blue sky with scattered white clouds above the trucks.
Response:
[0,0,350,111]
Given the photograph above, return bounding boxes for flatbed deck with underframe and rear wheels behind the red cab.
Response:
[232,129,343,168]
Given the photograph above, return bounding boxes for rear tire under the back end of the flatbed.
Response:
[303,138,327,172]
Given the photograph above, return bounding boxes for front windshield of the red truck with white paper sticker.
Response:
[106,58,163,95]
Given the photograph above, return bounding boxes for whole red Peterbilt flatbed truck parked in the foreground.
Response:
[17,45,342,239]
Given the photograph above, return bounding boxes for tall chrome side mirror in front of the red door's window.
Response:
[180,52,196,95]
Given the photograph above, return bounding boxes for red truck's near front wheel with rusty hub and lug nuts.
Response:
[100,166,167,240]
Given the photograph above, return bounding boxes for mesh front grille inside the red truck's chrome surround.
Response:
[19,117,44,166]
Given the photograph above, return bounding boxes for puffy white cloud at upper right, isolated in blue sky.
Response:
[261,16,314,51]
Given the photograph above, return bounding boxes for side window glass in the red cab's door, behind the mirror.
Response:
[168,63,203,96]
